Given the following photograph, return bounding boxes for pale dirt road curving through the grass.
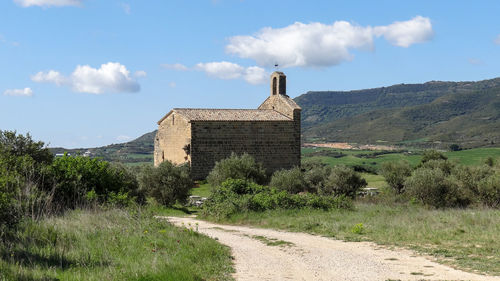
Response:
[166,217,500,281]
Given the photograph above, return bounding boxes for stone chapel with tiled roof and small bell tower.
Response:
[154,71,301,180]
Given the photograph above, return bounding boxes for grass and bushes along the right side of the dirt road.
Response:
[198,149,500,275]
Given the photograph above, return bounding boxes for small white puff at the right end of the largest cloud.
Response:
[374,16,434,48]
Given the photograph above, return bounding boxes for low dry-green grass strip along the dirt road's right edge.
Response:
[204,203,500,275]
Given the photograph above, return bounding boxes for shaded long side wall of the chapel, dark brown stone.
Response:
[191,119,300,179]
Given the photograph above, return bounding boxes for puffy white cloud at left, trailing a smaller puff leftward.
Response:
[31,62,140,94]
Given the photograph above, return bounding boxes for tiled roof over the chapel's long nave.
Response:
[158,108,292,123]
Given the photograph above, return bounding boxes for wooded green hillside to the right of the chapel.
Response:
[295,75,500,148]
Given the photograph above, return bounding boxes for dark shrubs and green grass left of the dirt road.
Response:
[0,131,233,280]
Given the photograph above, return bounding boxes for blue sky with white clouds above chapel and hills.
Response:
[0,0,500,148]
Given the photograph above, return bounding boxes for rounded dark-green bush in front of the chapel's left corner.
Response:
[139,161,194,206]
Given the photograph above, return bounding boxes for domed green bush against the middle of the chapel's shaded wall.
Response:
[207,153,267,187]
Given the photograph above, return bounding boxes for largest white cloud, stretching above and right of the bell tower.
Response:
[226,16,433,67]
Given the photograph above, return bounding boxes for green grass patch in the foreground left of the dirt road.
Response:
[0,209,233,280]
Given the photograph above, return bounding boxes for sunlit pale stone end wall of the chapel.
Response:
[154,113,191,166]
